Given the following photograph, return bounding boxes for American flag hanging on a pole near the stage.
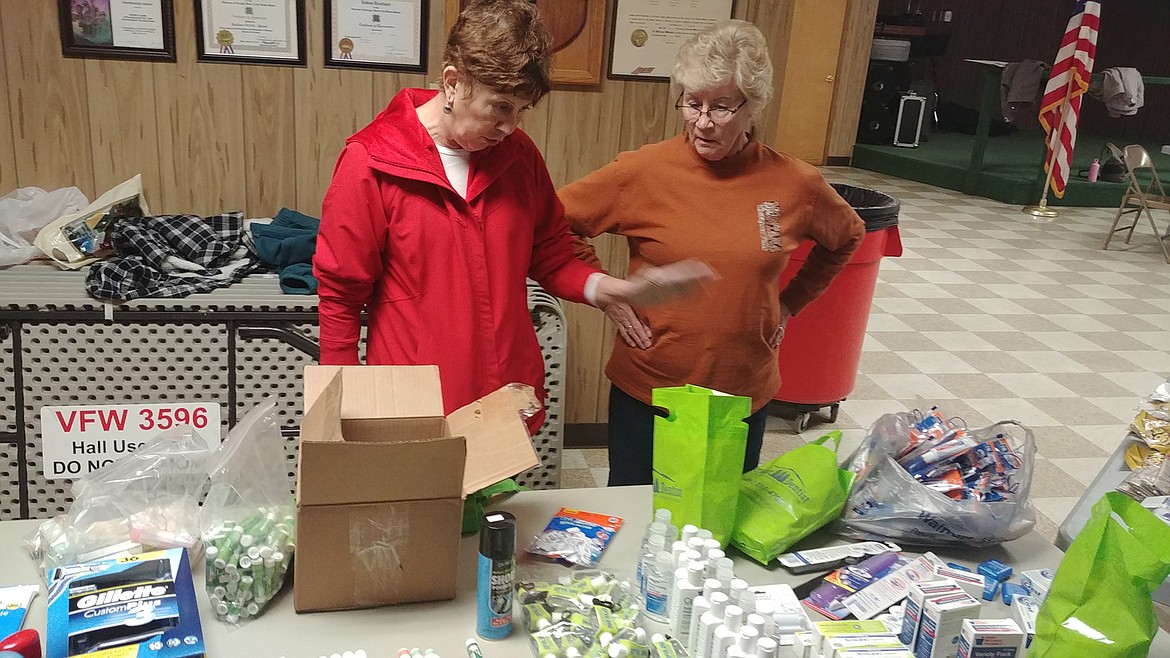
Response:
[1040,0,1101,198]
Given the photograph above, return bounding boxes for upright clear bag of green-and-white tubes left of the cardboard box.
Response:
[202,400,296,626]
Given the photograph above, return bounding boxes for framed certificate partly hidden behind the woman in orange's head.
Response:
[608,0,735,81]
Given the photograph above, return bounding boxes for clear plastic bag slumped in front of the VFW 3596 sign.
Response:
[28,427,212,577]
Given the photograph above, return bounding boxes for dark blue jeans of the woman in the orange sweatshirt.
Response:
[608,385,768,487]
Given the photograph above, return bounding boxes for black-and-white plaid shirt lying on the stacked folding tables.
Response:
[85,212,261,302]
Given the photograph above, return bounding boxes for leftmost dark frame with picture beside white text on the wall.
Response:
[57,0,174,62]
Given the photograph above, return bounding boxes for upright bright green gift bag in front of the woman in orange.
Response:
[651,384,751,543]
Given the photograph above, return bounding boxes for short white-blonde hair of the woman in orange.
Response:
[670,20,772,114]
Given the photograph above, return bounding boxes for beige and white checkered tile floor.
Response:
[563,167,1170,540]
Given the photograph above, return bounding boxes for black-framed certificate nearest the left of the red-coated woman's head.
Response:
[324,0,431,73]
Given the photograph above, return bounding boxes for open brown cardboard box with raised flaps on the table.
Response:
[293,365,539,612]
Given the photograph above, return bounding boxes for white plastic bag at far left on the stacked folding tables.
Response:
[0,182,89,267]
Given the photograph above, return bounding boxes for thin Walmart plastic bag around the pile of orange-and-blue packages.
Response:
[835,413,1035,547]
